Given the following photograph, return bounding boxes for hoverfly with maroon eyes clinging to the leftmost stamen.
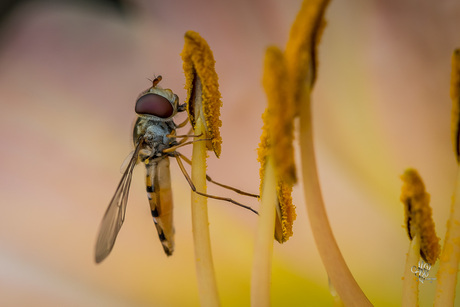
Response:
[95,76,259,263]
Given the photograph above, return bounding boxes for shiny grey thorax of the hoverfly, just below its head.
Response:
[133,117,176,159]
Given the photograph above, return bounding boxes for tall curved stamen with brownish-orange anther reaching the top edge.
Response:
[286,0,371,306]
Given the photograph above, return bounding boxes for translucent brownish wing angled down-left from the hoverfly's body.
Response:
[96,139,143,263]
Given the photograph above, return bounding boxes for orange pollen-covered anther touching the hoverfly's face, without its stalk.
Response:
[181,31,222,157]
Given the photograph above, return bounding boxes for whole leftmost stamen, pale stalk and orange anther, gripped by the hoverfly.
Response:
[178,31,222,306]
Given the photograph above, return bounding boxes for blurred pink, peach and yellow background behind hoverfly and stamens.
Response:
[0,0,460,306]
